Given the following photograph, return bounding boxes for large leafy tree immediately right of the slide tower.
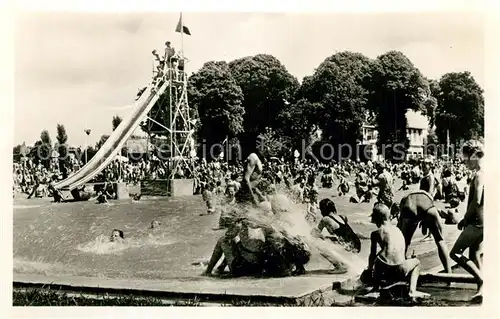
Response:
[188,61,245,160]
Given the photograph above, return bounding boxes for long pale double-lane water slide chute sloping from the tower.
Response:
[54,81,168,198]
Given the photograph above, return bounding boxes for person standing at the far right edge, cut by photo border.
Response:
[450,141,484,299]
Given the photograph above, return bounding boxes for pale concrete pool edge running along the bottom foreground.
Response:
[13,244,458,304]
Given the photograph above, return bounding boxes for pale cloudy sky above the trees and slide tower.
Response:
[14,12,485,146]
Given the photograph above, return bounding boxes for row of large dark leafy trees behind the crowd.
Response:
[143,51,484,162]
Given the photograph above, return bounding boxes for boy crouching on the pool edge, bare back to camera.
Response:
[368,203,428,298]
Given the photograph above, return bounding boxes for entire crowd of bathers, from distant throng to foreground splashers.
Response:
[14,136,484,302]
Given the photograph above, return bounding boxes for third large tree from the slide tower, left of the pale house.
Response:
[299,52,370,161]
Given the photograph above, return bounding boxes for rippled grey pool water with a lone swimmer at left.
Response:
[13,185,462,279]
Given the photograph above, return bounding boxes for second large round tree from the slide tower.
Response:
[229,54,299,136]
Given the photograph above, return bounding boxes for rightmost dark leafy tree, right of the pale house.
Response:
[436,72,484,144]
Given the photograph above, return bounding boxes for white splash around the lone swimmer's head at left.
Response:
[76,234,176,255]
